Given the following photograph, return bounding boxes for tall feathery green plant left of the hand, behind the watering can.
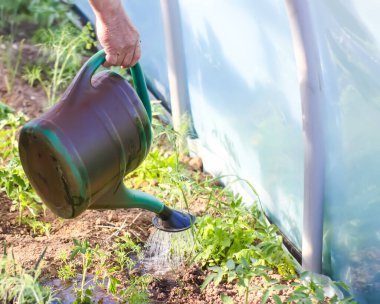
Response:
[23,24,94,105]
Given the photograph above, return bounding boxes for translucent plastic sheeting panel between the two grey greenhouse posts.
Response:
[180,0,303,247]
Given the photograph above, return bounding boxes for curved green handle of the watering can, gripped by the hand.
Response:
[79,50,152,121]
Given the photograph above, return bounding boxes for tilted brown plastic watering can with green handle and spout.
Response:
[19,50,195,232]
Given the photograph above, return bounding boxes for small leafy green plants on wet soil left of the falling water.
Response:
[58,234,151,304]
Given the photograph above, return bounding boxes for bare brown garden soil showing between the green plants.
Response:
[0,41,296,304]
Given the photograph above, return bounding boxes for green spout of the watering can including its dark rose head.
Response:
[89,185,195,232]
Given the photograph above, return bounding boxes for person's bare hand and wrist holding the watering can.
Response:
[89,0,141,68]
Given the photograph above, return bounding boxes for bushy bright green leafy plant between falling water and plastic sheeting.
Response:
[195,197,295,276]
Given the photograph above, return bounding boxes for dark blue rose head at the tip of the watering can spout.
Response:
[152,206,196,232]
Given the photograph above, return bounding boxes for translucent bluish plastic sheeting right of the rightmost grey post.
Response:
[310,0,380,303]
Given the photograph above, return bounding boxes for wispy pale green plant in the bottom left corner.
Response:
[0,244,55,304]
